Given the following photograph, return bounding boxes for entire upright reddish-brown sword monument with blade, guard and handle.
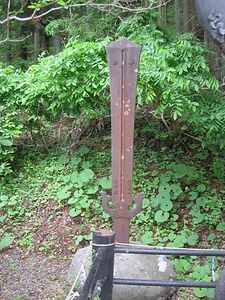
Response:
[102,38,143,243]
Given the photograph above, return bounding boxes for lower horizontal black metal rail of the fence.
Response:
[113,278,217,288]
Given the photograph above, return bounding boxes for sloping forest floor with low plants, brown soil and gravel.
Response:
[0,125,225,300]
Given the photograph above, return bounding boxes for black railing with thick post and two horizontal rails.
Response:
[79,230,225,300]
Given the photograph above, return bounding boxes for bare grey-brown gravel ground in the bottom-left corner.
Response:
[0,247,71,300]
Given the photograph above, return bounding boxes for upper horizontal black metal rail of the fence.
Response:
[114,247,225,256]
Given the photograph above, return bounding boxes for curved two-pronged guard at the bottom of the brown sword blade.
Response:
[100,191,144,219]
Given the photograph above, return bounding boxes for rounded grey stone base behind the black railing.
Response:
[68,247,176,300]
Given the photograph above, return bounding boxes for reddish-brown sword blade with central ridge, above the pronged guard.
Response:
[106,39,141,205]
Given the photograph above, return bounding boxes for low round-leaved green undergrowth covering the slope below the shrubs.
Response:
[0,118,225,299]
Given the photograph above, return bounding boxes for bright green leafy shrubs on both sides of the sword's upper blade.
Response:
[0,13,225,172]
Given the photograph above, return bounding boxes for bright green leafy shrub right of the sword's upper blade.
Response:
[118,14,225,151]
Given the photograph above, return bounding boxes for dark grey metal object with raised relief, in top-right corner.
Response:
[196,0,225,44]
